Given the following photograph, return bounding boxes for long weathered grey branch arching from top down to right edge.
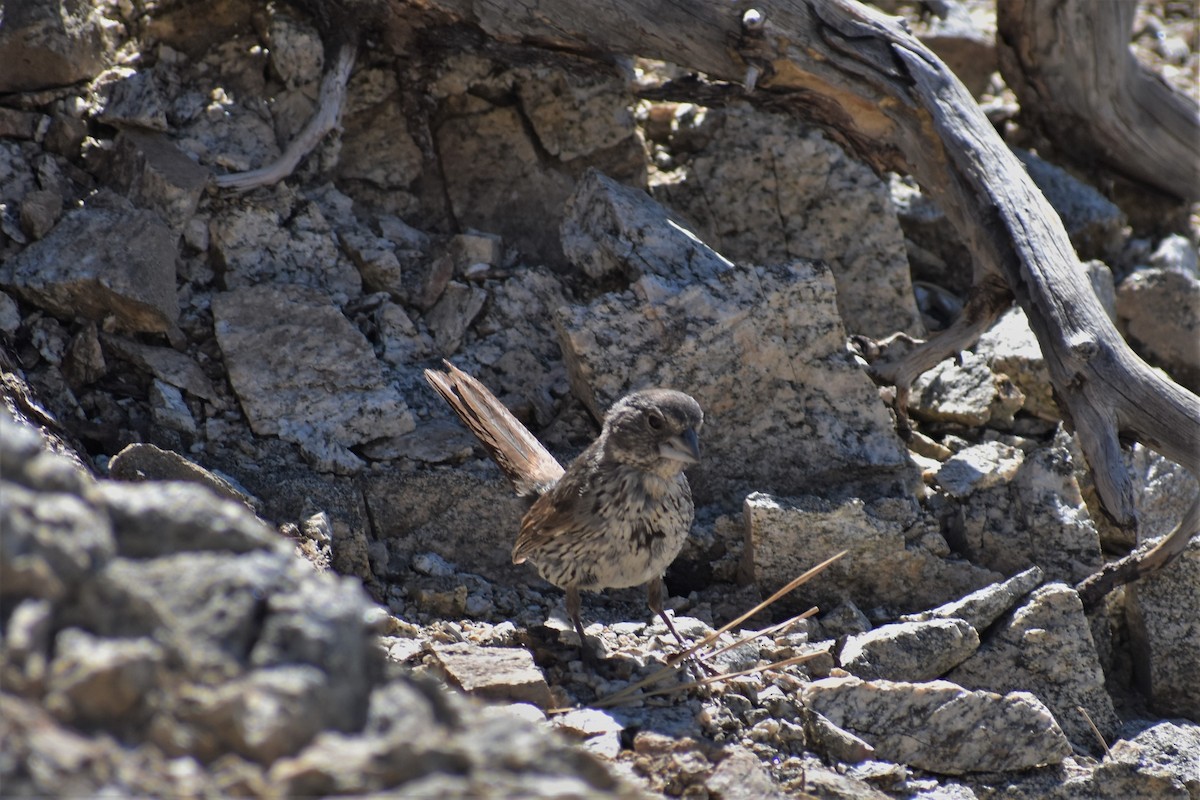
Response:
[238,0,1200,603]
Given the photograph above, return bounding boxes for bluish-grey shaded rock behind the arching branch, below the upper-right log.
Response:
[1013,148,1127,261]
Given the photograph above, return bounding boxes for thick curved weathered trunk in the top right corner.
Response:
[996,0,1200,200]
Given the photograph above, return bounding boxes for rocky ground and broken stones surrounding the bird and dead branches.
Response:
[0,0,1200,800]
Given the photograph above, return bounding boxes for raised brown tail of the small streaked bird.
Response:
[425,361,563,495]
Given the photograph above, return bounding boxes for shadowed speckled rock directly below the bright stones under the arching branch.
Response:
[934,434,1102,584]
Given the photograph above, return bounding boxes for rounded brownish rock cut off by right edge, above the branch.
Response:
[1117,269,1200,391]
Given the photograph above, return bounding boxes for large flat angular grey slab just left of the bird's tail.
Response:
[212,285,415,474]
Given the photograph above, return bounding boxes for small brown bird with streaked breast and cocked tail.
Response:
[425,362,704,657]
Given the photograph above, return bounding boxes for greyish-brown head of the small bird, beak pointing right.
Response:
[602,389,704,475]
